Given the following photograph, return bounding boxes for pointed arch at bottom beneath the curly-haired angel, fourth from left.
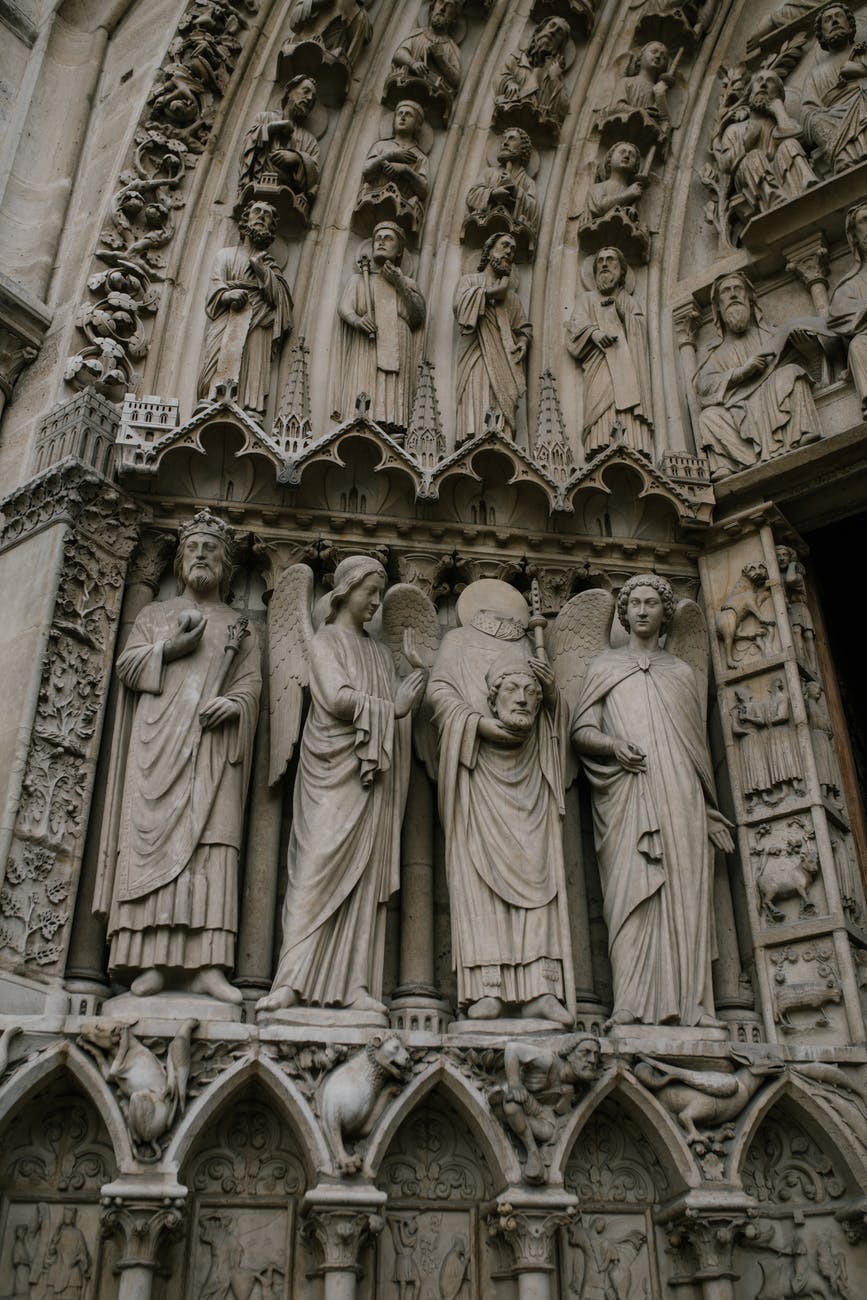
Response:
[549,1066,701,1197]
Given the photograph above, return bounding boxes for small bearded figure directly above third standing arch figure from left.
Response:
[460,126,538,257]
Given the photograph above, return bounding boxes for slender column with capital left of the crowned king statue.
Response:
[65,529,177,1011]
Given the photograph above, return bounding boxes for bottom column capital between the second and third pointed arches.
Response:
[302,1187,386,1300]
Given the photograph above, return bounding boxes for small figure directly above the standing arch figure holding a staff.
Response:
[352,99,428,239]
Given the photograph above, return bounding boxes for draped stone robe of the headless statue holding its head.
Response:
[428,620,573,1006]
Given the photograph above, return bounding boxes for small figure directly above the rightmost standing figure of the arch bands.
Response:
[578,140,651,264]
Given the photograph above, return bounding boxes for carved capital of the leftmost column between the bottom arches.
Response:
[101,1184,185,1300]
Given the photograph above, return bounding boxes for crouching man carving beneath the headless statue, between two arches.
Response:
[487,1037,599,1183]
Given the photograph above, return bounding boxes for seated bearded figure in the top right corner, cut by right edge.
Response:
[802,3,867,174]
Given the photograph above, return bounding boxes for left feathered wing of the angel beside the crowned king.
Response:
[268,564,313,785]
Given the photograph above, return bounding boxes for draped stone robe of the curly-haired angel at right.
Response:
[572,647,715,1024]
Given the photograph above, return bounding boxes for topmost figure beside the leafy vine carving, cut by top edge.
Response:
[277,0,373,107]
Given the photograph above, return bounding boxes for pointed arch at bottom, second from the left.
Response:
[164,1057,337,1183]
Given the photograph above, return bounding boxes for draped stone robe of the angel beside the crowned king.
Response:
[274,624,411,1005]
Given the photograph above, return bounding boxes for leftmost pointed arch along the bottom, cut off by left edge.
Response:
[0,1040,138,1174]
